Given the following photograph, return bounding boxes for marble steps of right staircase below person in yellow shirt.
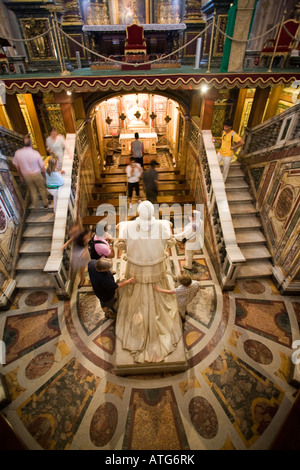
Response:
[225,162,272,279]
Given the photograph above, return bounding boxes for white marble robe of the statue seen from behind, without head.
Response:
[116,209,182,363]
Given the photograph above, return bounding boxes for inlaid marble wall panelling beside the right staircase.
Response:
[243,147,300,293]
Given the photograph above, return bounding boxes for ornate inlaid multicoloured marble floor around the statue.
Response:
[0,245,300,450]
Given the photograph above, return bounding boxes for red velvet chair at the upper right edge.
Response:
[258,20,299,68]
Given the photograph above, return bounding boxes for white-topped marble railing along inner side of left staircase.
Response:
[44,123,88,299]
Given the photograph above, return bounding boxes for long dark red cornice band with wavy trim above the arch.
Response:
[2,72,300,94]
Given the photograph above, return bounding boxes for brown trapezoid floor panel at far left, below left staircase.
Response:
[3,308,61,364]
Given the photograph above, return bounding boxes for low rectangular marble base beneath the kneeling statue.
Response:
[114,337,188,375]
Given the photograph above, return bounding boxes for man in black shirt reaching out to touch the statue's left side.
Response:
[88,258,136,318]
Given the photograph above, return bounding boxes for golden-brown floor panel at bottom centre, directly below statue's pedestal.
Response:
[123,387,189,450]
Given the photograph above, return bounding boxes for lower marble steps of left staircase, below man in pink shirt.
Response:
[16,208,55,289]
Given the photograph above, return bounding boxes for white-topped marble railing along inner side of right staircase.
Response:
[190,121,246,290]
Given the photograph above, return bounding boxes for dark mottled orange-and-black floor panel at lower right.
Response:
[202,351,284,448]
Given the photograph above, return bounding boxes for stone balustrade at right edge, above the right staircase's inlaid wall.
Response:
[239,103,300,160]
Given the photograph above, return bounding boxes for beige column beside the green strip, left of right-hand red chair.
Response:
[228,0,255,72]
